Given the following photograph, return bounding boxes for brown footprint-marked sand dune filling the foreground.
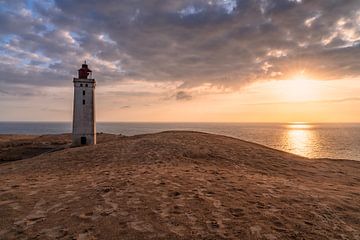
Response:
[0,132,360,240]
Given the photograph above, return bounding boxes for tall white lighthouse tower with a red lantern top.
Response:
[72,61,96,146]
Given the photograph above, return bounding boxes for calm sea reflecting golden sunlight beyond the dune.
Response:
[0,122,360,161]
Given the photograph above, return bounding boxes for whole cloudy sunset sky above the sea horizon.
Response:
[0,0,360,122]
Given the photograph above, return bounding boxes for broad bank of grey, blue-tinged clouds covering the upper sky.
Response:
[0,0,360,90]
